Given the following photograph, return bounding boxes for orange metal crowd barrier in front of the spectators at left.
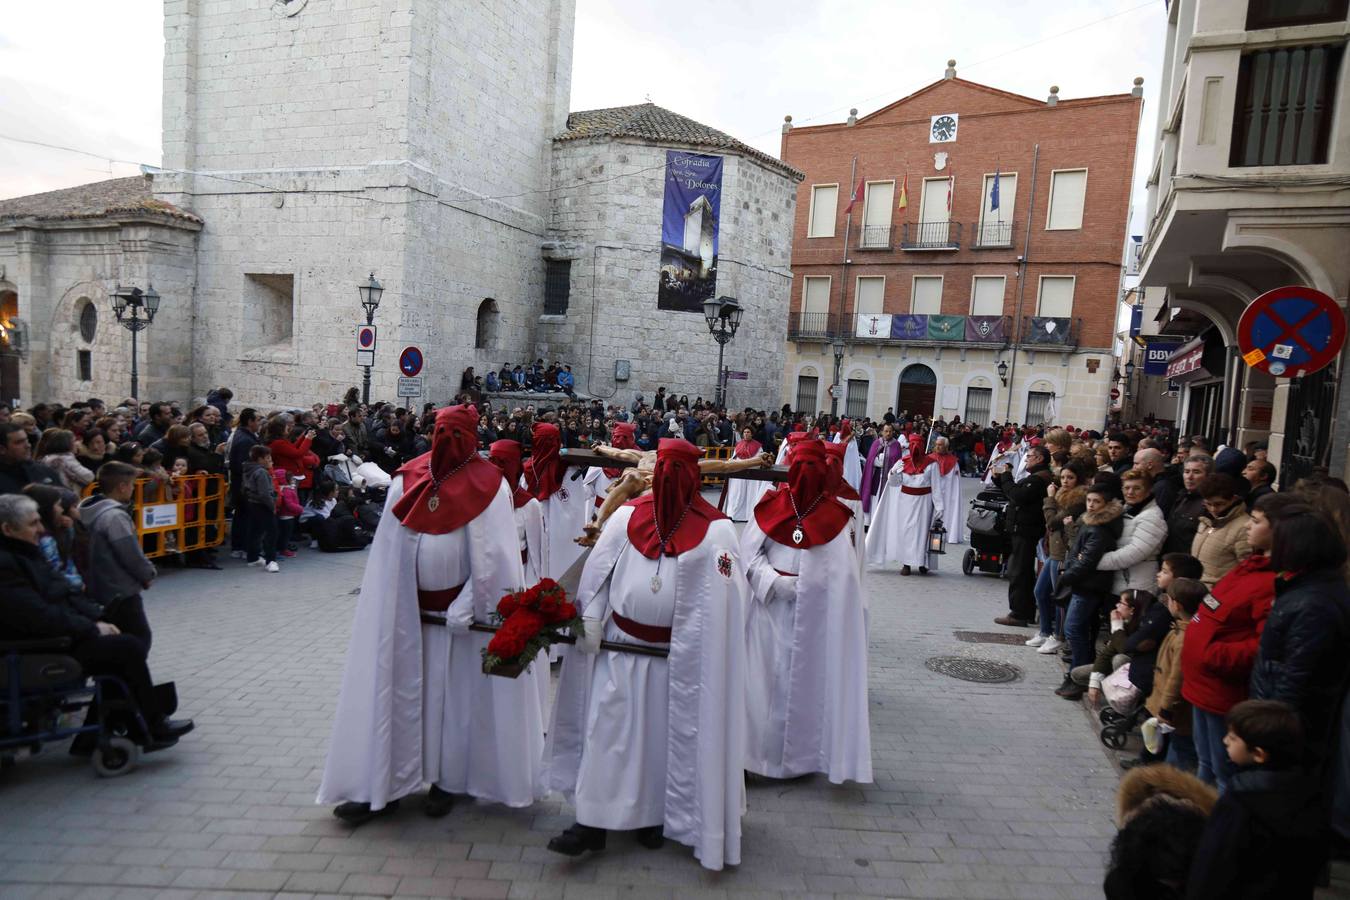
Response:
[85,475,225,559]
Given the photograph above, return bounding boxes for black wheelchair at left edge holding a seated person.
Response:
[0,638,178,777]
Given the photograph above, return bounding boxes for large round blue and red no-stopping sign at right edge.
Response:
[1238,286,1346,378]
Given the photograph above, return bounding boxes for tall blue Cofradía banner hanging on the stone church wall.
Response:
[656,150,722,313]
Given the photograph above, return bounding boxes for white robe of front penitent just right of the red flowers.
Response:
[544,506,749,869]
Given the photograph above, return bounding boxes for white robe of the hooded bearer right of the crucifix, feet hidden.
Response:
[741,518,872,784]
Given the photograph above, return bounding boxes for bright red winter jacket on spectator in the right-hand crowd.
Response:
[1181,553,1274,715]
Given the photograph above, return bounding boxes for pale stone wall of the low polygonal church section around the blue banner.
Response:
[536,139,797,407]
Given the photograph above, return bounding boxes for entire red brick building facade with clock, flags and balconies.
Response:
[782,63,1142,426]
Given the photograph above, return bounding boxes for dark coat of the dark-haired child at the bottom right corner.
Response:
[1185,766,1326,900]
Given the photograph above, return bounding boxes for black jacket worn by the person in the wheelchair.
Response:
[0,536,103,641]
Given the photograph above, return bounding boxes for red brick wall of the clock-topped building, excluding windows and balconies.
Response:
[782,80,1142,348]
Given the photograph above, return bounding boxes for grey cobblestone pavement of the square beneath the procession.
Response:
[0,480,1350,900]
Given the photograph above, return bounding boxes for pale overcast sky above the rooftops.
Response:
[0,0,1166,210]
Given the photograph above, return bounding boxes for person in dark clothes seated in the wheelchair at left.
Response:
[0,494,193,750]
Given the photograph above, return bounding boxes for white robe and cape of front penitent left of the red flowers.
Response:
[319,476,544,810]
